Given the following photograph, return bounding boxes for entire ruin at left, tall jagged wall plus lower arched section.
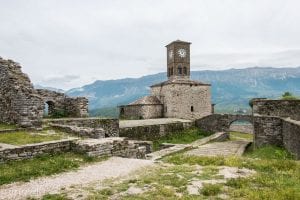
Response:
[0,57,88,128]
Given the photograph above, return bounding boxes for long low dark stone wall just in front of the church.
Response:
[120,122,194,141]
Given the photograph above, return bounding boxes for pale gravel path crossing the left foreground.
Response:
[0,157,153,200]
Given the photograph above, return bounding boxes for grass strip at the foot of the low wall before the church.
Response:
[153,128,211,150]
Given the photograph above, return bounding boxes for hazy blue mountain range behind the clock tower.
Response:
[66,67,300,114]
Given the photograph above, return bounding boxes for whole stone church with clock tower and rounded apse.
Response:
[119,40,213,119]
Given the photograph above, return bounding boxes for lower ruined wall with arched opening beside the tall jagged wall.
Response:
[36,89,88,117]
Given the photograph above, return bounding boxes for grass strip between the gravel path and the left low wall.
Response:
[0,153,104,185]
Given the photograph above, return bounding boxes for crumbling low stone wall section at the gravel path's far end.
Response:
[74,137,147,158]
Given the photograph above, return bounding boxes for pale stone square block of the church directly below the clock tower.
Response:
[151,83,212,119]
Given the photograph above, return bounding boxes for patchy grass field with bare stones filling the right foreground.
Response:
[81,146,300,200]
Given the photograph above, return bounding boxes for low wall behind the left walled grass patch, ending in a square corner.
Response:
[45,118,119,137]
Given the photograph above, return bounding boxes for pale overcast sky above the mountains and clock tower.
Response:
[0,0,300,89]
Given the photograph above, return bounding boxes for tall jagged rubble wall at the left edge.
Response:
[0,57,43,128]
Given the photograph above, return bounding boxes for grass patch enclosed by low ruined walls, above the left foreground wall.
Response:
[0,130,66,145]
